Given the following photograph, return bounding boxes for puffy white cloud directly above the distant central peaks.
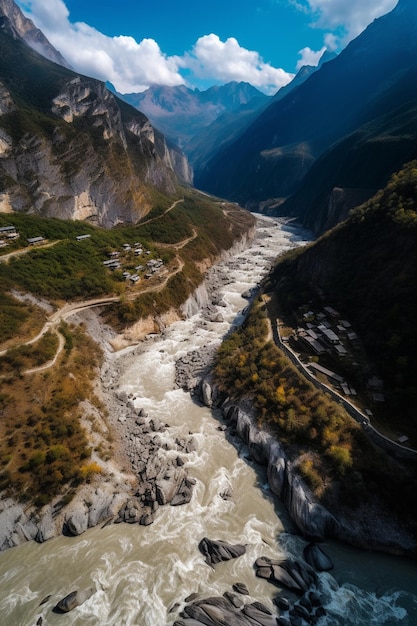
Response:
[179,33,294,93]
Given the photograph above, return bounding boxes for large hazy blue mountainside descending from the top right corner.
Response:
[195,0,417,222]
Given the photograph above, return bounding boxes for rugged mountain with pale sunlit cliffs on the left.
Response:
[0,11,190,227]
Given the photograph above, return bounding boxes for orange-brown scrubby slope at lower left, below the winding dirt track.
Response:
[0,328,100,506]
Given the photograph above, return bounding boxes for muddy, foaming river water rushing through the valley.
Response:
[0,218,417,626]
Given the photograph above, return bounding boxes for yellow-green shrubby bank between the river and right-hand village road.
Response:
[214,296,416,520]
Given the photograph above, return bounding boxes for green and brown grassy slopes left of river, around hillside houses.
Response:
[0,191,254,504]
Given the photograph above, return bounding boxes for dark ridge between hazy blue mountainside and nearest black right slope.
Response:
[279,64,417,234]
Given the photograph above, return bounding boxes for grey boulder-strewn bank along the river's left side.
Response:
[0,216,255,551]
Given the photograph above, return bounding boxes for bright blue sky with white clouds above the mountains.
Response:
[17,0,397,94]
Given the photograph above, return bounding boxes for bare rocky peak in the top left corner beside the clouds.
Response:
[0,0,70,68]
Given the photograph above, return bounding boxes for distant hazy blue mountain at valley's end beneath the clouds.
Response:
[118,82,267,148]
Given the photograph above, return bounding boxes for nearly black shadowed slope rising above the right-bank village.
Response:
[272,161,417,434]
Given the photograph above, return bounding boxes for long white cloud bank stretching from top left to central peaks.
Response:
[18,0,293,93]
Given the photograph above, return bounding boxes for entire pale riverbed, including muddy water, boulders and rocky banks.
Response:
[0,216,413,626]
